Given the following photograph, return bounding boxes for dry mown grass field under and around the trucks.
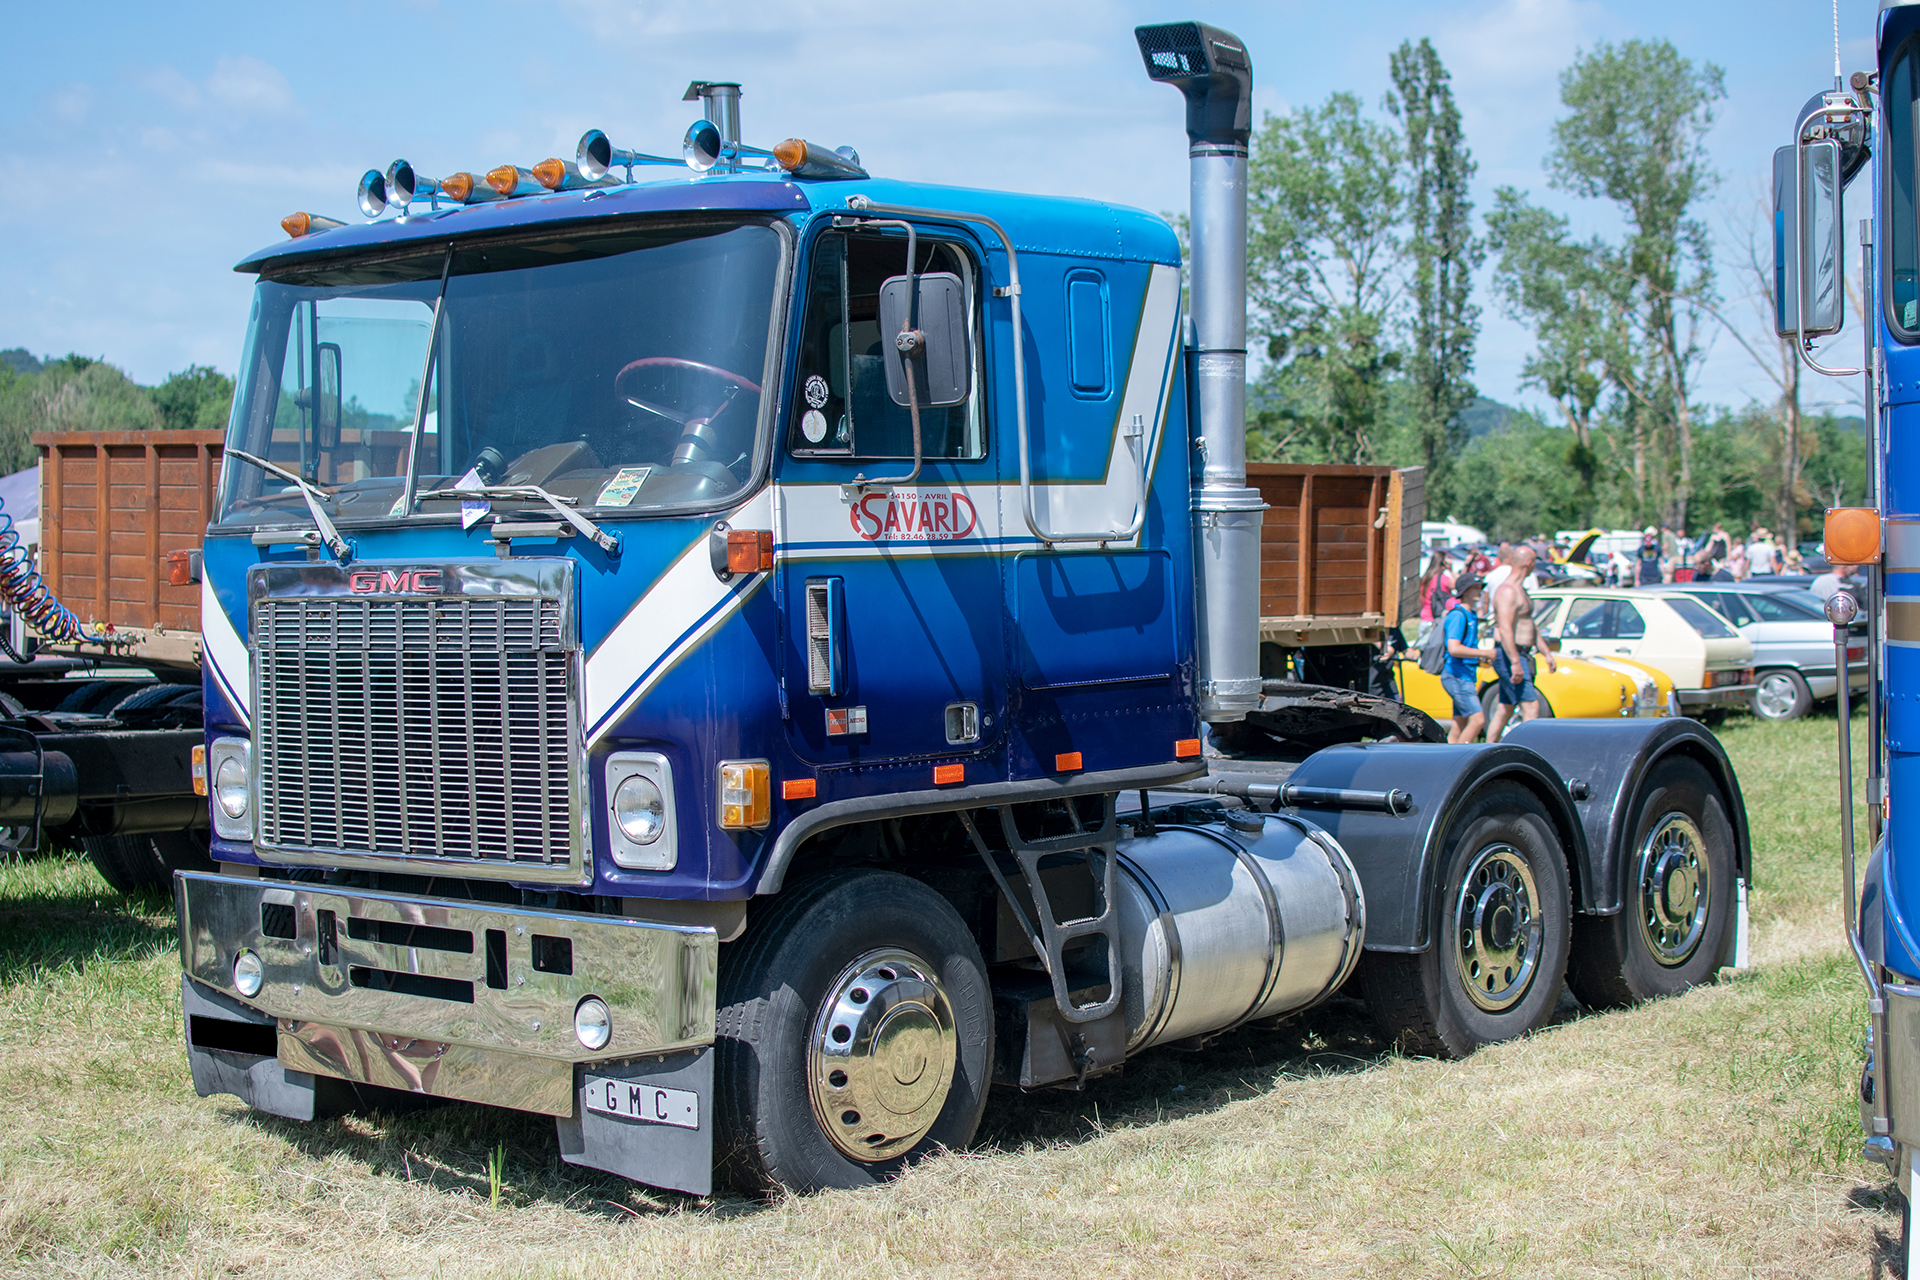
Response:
[0,714,1899,1278]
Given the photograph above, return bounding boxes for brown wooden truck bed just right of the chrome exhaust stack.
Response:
[1246,462,1427,647]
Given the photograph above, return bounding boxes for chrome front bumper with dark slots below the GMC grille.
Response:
[175,873,720,1115]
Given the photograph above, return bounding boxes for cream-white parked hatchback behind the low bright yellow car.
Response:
[1534,587,1753,716]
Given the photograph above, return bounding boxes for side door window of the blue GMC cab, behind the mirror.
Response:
[787,230,987,461]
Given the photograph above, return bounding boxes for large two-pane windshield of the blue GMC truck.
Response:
[221,223,783,526]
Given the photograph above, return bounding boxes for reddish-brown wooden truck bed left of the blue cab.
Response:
[33,432,223,666]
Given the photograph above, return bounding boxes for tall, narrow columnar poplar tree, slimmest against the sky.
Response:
[1388,36,1486,495]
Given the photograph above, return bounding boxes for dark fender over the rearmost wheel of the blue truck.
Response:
[1507,716,1753,915]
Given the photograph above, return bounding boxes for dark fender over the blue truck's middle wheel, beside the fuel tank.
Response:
[1286,743,1588,952]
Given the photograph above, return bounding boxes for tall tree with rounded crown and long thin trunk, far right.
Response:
[1546,40,1726,524]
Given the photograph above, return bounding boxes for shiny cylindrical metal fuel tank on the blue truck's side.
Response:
[1117,810,1367,1054]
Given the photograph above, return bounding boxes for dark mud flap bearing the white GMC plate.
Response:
[555,1044,714,1196]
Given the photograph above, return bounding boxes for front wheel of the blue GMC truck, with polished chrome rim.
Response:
[714,869,993,1194]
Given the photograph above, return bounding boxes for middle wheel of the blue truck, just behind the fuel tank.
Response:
[1365,783,1572,1057]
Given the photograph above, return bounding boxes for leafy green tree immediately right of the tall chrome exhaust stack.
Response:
[1246,94,1405,462]
